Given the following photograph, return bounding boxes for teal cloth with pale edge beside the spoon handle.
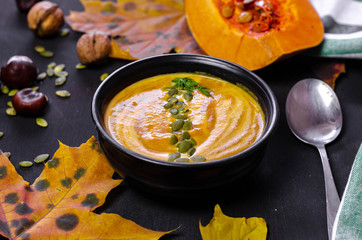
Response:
[332,144,362,240]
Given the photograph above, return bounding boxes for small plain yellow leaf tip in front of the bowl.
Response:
[199,204,267,240]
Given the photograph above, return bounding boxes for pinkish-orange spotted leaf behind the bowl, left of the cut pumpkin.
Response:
[66,0,203,60]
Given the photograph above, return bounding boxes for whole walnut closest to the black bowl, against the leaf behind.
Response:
[77,32,111,65]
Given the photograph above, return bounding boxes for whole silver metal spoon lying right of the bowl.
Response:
[286,78,342,239]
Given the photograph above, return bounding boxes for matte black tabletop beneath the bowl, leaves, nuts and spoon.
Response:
[0,0,362,240]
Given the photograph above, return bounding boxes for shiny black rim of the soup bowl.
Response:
[91,53,279,168]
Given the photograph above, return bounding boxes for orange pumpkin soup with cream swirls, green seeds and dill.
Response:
[105,73,265,162]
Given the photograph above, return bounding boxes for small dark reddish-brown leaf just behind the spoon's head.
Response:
[311,59,346,89]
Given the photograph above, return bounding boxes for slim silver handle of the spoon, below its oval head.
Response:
[317,146,340,239]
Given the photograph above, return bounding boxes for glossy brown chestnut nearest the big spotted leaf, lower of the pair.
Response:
[12,88,48,116]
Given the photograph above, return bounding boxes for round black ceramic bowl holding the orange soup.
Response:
[92,54,279,192]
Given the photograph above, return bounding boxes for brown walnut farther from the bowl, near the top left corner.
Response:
[28,1,64,37]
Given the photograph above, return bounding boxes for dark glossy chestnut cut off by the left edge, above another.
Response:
[1,56,38,89]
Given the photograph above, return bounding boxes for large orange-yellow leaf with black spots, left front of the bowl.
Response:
[0,137,166,240]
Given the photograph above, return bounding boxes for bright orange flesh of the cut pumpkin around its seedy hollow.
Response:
[185,0,324,71]
